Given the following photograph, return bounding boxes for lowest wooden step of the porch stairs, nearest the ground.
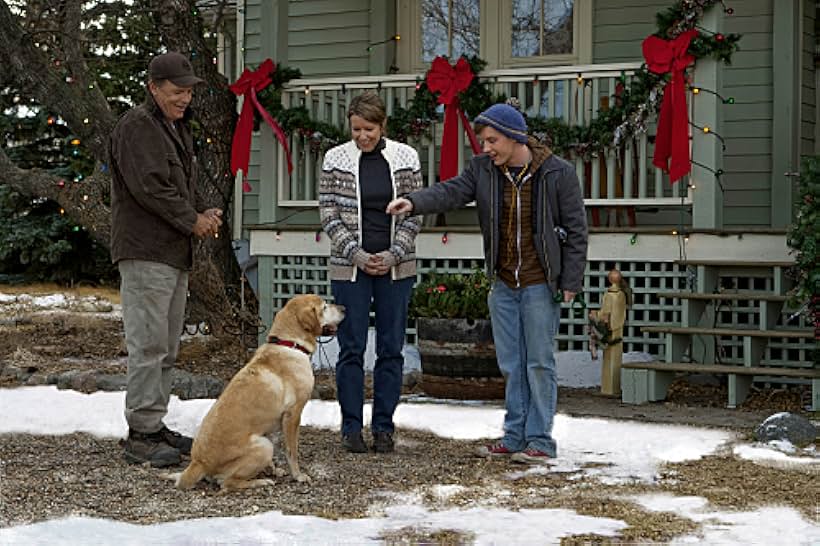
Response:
[621,362,820,411]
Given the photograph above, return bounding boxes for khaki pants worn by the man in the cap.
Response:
[118,260,188,434]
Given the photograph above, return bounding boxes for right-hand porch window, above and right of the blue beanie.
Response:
[510,0,574,57]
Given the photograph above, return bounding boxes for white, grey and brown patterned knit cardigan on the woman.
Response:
[319,138,422,281]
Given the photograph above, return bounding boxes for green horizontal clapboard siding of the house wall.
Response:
[243,0,816,231]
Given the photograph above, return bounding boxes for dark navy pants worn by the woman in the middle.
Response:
[330,270,415,435]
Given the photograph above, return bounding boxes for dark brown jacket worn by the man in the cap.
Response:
[111,96,204,270]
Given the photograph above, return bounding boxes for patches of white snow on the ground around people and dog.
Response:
[0,387,820,545]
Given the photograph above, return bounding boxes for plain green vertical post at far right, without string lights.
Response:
[771,0,801,227]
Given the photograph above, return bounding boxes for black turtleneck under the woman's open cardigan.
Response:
[359,139,393,254]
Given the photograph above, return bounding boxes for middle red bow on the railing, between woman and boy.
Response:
[427,56,481,181]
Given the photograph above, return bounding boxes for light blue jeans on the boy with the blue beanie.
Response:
[487,280,561,457]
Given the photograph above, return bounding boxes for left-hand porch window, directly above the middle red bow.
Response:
[421,0,481,63]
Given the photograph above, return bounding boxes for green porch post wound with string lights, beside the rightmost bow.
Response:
[692,6,725,229]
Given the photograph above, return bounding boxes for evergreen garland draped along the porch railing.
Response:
[253,0,740,157]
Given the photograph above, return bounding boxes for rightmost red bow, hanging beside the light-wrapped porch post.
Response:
[643,29,698,184]
